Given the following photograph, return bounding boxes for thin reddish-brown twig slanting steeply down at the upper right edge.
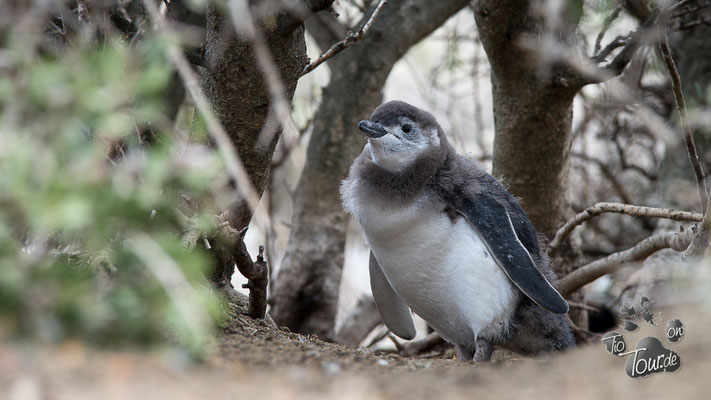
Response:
[658,21,709,213]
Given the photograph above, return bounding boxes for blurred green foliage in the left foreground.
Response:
[0,27,226,355]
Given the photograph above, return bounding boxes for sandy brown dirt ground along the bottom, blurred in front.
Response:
[0,296,711,400]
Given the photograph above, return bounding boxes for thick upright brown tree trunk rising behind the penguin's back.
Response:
[474,0,579,241]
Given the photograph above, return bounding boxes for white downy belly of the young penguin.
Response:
[356,195,518,346]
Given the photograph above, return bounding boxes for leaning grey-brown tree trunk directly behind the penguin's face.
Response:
[270,0,467,339]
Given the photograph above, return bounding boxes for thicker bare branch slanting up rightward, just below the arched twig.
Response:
[556,231,691,296]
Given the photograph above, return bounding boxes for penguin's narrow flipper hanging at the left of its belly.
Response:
[369,251,417,340]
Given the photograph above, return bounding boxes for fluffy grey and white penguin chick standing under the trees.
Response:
[341,101,575,362]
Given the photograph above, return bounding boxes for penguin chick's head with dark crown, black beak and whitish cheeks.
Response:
[358,101,446,172]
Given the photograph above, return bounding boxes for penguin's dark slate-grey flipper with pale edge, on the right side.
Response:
[458,195,568,314]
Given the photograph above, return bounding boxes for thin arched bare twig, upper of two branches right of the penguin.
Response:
[548,203,703,254]
